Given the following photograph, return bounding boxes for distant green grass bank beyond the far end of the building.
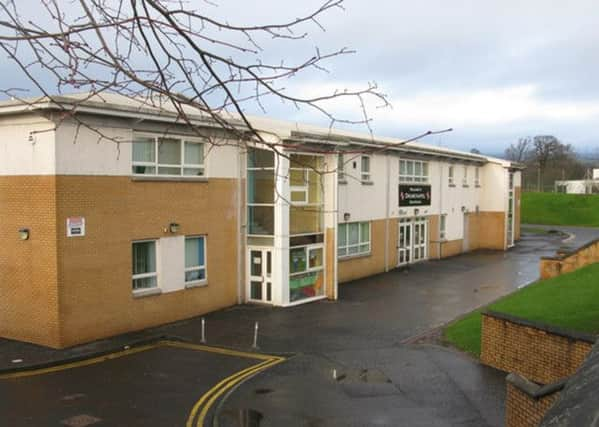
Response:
[521,192,599,227]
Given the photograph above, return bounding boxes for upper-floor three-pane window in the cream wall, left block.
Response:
[132,137,205,177]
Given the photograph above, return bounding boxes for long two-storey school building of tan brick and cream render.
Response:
[0,94,521,348]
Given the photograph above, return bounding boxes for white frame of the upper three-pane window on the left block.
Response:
[131,134,206,179]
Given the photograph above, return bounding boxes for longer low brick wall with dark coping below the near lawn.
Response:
[480,311,595,384]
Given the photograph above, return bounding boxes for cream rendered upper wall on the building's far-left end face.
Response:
[0,115,56,175]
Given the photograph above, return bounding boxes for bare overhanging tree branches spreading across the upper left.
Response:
[0,0,388,149]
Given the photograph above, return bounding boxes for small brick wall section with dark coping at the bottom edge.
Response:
[505,374,564,427]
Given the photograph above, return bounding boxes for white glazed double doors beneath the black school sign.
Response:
[397,218,428,266]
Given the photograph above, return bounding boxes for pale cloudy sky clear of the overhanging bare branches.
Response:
[0,0,599,153]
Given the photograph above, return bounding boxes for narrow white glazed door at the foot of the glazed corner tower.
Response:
[247,248,272,304]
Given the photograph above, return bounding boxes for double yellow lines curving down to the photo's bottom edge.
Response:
[186,353,285,427]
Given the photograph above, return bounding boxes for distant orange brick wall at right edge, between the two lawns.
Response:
[540,239,599,279]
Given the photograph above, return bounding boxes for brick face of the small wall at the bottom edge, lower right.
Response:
[505,381,559,427]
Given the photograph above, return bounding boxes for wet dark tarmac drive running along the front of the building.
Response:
[0,227,584,426]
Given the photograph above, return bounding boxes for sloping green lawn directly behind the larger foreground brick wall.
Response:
[443,263,599,357]
